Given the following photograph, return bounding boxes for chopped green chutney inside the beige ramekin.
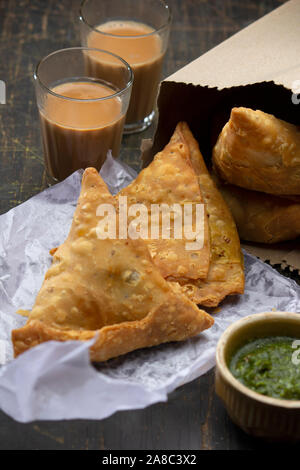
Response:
[229,336,300,400]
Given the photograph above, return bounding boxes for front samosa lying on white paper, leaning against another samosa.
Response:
[12,168,213,361]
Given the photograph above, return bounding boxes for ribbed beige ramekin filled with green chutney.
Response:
[215,311,300,441]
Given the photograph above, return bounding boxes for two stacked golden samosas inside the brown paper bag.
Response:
[213,107,300,243]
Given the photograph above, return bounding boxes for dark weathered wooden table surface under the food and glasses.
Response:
[0,0,296,450]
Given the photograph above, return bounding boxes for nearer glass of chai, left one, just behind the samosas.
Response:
[34,47,133,184]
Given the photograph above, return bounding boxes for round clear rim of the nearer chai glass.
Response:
[33,46,134,103]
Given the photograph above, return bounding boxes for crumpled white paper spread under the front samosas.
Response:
[0,152,300,422]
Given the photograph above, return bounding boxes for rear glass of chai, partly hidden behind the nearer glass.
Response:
[79,0,171,134]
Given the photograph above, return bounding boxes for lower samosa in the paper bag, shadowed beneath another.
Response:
[214,176,300,243]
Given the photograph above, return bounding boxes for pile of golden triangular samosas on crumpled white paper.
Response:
[12,123,244,361]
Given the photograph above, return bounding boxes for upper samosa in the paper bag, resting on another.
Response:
[213,107,300,195]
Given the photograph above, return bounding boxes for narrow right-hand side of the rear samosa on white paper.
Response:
[169,122,245,307]
